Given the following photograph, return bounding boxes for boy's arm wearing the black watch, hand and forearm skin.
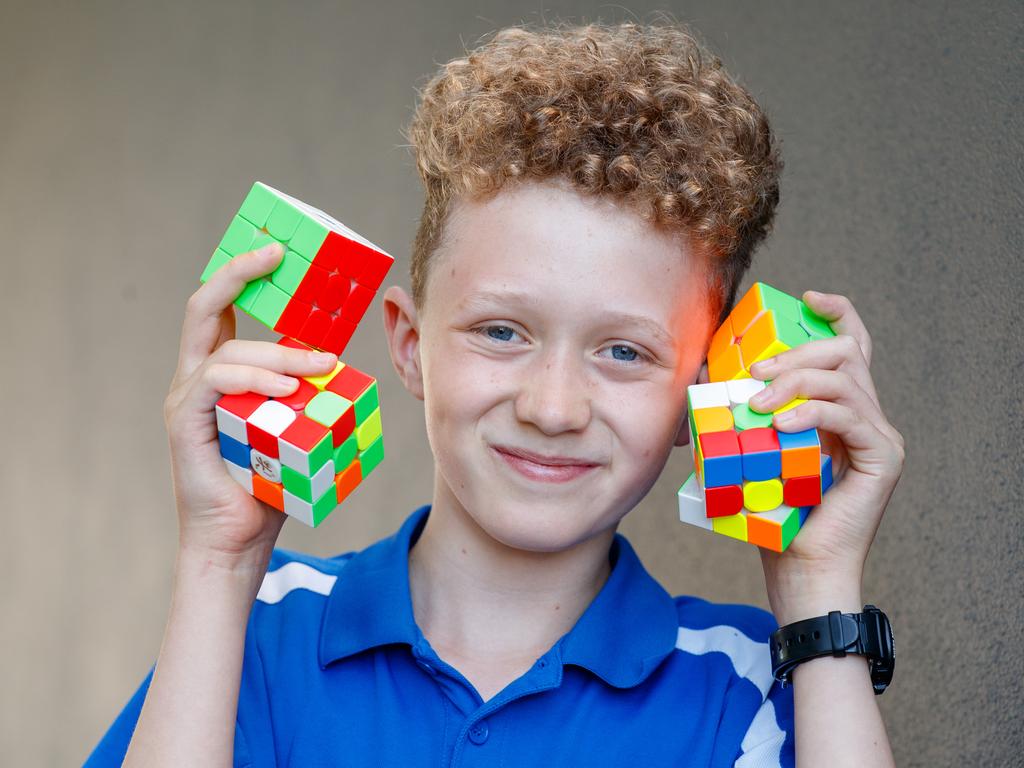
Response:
[751,292,904,766]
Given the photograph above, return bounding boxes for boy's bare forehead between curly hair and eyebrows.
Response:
[428,182,708,325]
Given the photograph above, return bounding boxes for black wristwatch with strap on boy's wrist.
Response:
[771,605,896,695]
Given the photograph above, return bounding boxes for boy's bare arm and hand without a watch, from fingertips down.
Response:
[112,244,337,768]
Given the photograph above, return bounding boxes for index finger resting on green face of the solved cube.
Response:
[178,243,284,378]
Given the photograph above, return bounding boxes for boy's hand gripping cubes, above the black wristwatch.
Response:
[750,291,904,625]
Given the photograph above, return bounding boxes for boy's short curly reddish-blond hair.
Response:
[406,23,782,315]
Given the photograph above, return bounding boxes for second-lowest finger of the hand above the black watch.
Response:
[750,369,897,440]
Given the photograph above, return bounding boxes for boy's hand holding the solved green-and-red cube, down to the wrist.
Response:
[164,244,338,566]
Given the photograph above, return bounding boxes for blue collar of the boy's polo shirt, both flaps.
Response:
[319,505,679,688]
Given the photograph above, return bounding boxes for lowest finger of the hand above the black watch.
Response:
[773,400,898,474]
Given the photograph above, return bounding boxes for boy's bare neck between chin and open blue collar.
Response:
[409,478,615,669]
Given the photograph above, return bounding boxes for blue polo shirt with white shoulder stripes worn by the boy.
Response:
[86,507,794,768]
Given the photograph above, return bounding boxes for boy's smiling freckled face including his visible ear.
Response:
[388,181,711,551]
